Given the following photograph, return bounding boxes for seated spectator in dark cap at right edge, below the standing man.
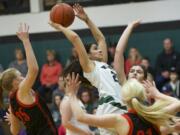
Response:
[162,67,180,99]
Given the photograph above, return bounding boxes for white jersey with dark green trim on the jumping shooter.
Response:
[83,61,126,135]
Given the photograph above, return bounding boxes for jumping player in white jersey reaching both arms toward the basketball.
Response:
[50,5,126,135]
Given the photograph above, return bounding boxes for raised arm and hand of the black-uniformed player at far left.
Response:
[17,24,39,96]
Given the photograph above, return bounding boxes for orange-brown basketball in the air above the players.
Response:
[50,3,75,27]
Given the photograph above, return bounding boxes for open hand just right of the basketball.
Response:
[73,4,88,22]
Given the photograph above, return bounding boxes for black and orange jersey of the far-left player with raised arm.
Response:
[10,91,58,135]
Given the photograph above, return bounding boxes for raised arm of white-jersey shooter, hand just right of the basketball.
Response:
[73,4,108,63]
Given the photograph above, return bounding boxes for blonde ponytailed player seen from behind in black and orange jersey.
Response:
[67,74,180,135]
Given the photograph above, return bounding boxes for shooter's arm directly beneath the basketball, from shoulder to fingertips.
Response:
[49,22,94,73]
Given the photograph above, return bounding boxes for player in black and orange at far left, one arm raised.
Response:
[0,24,58,135]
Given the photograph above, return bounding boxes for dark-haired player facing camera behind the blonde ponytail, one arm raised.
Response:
[114,20,180,133]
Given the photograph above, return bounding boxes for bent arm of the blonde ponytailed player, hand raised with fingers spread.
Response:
[67,74,123,129]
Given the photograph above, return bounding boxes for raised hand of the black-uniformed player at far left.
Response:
[16,23,29,41]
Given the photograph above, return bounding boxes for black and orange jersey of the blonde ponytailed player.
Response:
[122,110,160,135]
